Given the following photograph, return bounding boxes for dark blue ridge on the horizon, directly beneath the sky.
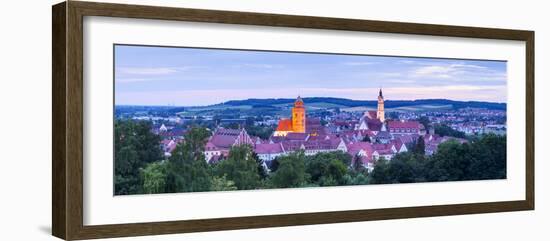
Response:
[219,97,506,110]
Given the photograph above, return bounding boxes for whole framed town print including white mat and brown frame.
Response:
[52,1,534,240]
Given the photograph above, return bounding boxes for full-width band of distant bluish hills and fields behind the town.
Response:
[115,97,506,118]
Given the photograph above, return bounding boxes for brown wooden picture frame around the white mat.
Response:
[52,1,535,240]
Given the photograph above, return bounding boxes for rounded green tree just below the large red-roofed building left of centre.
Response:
[216,145,260,190]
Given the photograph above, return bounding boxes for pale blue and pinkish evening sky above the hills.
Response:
[115,45,507,106]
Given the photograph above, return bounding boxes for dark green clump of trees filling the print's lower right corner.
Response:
[369,134,506,183]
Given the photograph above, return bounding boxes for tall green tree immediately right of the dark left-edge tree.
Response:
[166,127,212,192]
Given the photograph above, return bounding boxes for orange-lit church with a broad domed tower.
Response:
[273,96,306,136]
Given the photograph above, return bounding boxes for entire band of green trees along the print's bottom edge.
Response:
[114,120,506,195]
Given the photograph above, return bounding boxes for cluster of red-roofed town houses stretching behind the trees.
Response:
[159,112,463,170]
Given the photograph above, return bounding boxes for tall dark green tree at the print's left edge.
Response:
[114,120,163,195]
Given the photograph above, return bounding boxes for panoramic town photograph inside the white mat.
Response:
[113,44,507,195]
